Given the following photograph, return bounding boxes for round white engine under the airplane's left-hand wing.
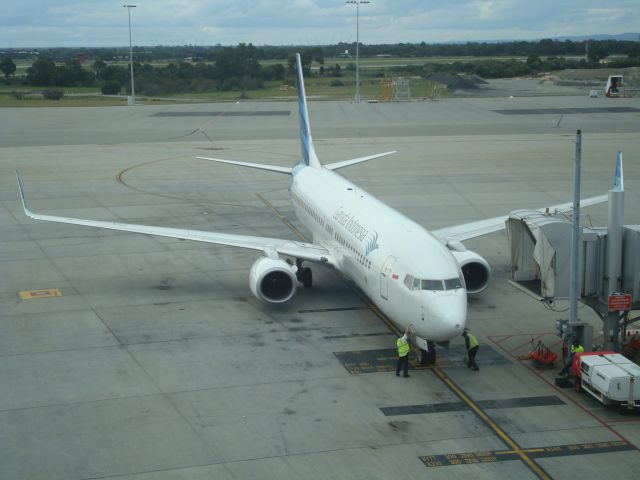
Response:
[249,257,298,303]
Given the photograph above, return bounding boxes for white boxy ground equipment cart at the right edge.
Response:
[580,352,640,409]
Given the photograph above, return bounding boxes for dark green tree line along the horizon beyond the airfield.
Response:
[0,39,640,96]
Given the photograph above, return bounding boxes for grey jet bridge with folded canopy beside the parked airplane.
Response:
[506,206,640,349]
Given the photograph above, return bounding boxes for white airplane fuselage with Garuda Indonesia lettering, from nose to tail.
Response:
[290,167,467,341]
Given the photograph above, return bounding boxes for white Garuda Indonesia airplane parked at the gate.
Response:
[16,54,607,361]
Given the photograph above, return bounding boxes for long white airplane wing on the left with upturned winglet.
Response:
[16,172,334,265]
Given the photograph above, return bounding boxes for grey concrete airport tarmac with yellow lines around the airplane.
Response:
[0,92,640,480]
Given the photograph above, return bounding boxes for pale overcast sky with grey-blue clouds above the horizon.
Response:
[0,0,640,48]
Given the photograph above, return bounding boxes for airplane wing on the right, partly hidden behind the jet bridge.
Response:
[431,195,609,243]
